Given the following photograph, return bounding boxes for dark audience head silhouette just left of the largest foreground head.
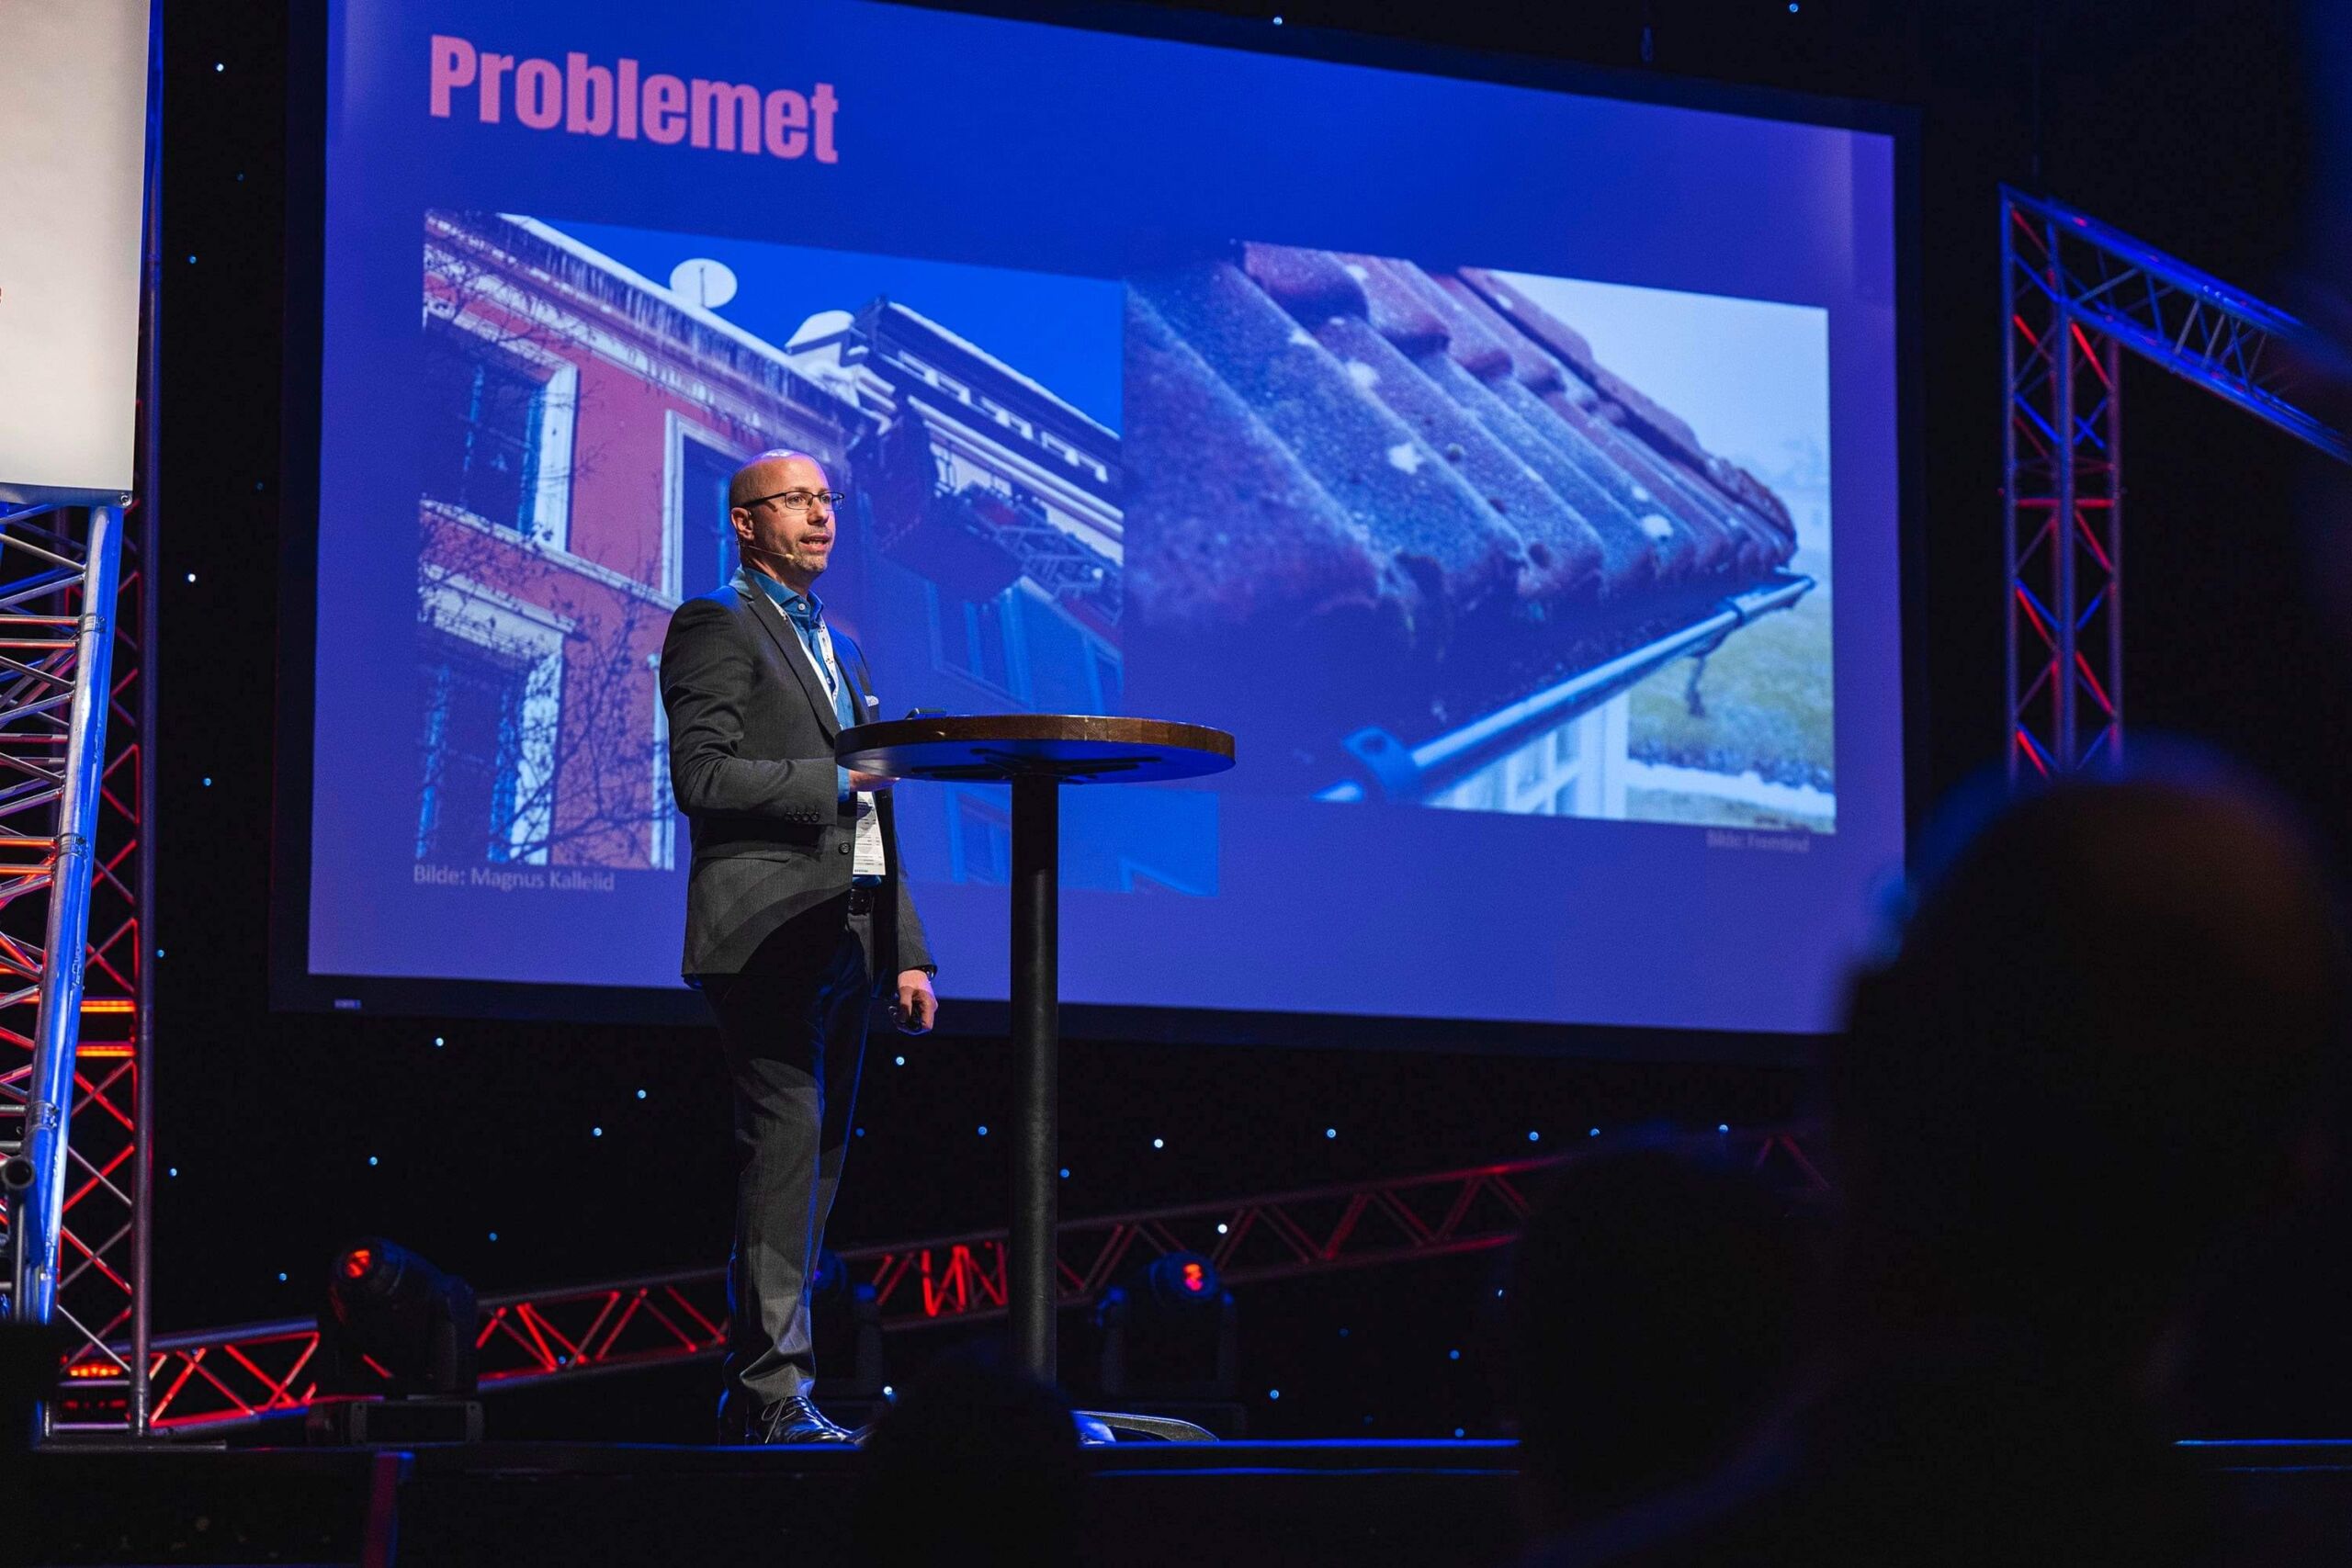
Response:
[1505,1147,1814,1528]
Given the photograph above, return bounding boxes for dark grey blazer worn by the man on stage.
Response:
[661,571,932,983]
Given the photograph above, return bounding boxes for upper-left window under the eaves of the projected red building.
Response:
[424,317,548,534]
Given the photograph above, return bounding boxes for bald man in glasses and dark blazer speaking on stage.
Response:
[661,451,938,1443]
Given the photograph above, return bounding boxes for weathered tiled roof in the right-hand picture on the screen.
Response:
[1125,244,1797,808]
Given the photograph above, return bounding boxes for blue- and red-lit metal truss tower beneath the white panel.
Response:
[0,505,153,1432]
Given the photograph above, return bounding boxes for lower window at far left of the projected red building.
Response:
[416,630,532,863]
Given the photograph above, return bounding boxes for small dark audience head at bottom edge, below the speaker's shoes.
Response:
[856,1349,1087,1568]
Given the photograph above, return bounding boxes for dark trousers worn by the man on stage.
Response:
[701,896,875,1438]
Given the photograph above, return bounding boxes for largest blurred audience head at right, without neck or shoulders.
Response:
[1827,752,2345,1375]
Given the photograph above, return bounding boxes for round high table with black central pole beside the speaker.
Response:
[832,712,1232,1382]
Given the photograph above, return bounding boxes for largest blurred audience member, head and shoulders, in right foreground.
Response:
[1505,752,2345,1568]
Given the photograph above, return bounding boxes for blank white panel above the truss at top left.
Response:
[0,0,148,501]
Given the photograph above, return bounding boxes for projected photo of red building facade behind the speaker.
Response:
[416,214,1214,891]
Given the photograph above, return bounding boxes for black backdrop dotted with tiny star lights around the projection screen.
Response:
[153,0,2352,1434]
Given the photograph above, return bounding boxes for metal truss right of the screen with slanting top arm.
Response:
[2002,186,2352,781]
